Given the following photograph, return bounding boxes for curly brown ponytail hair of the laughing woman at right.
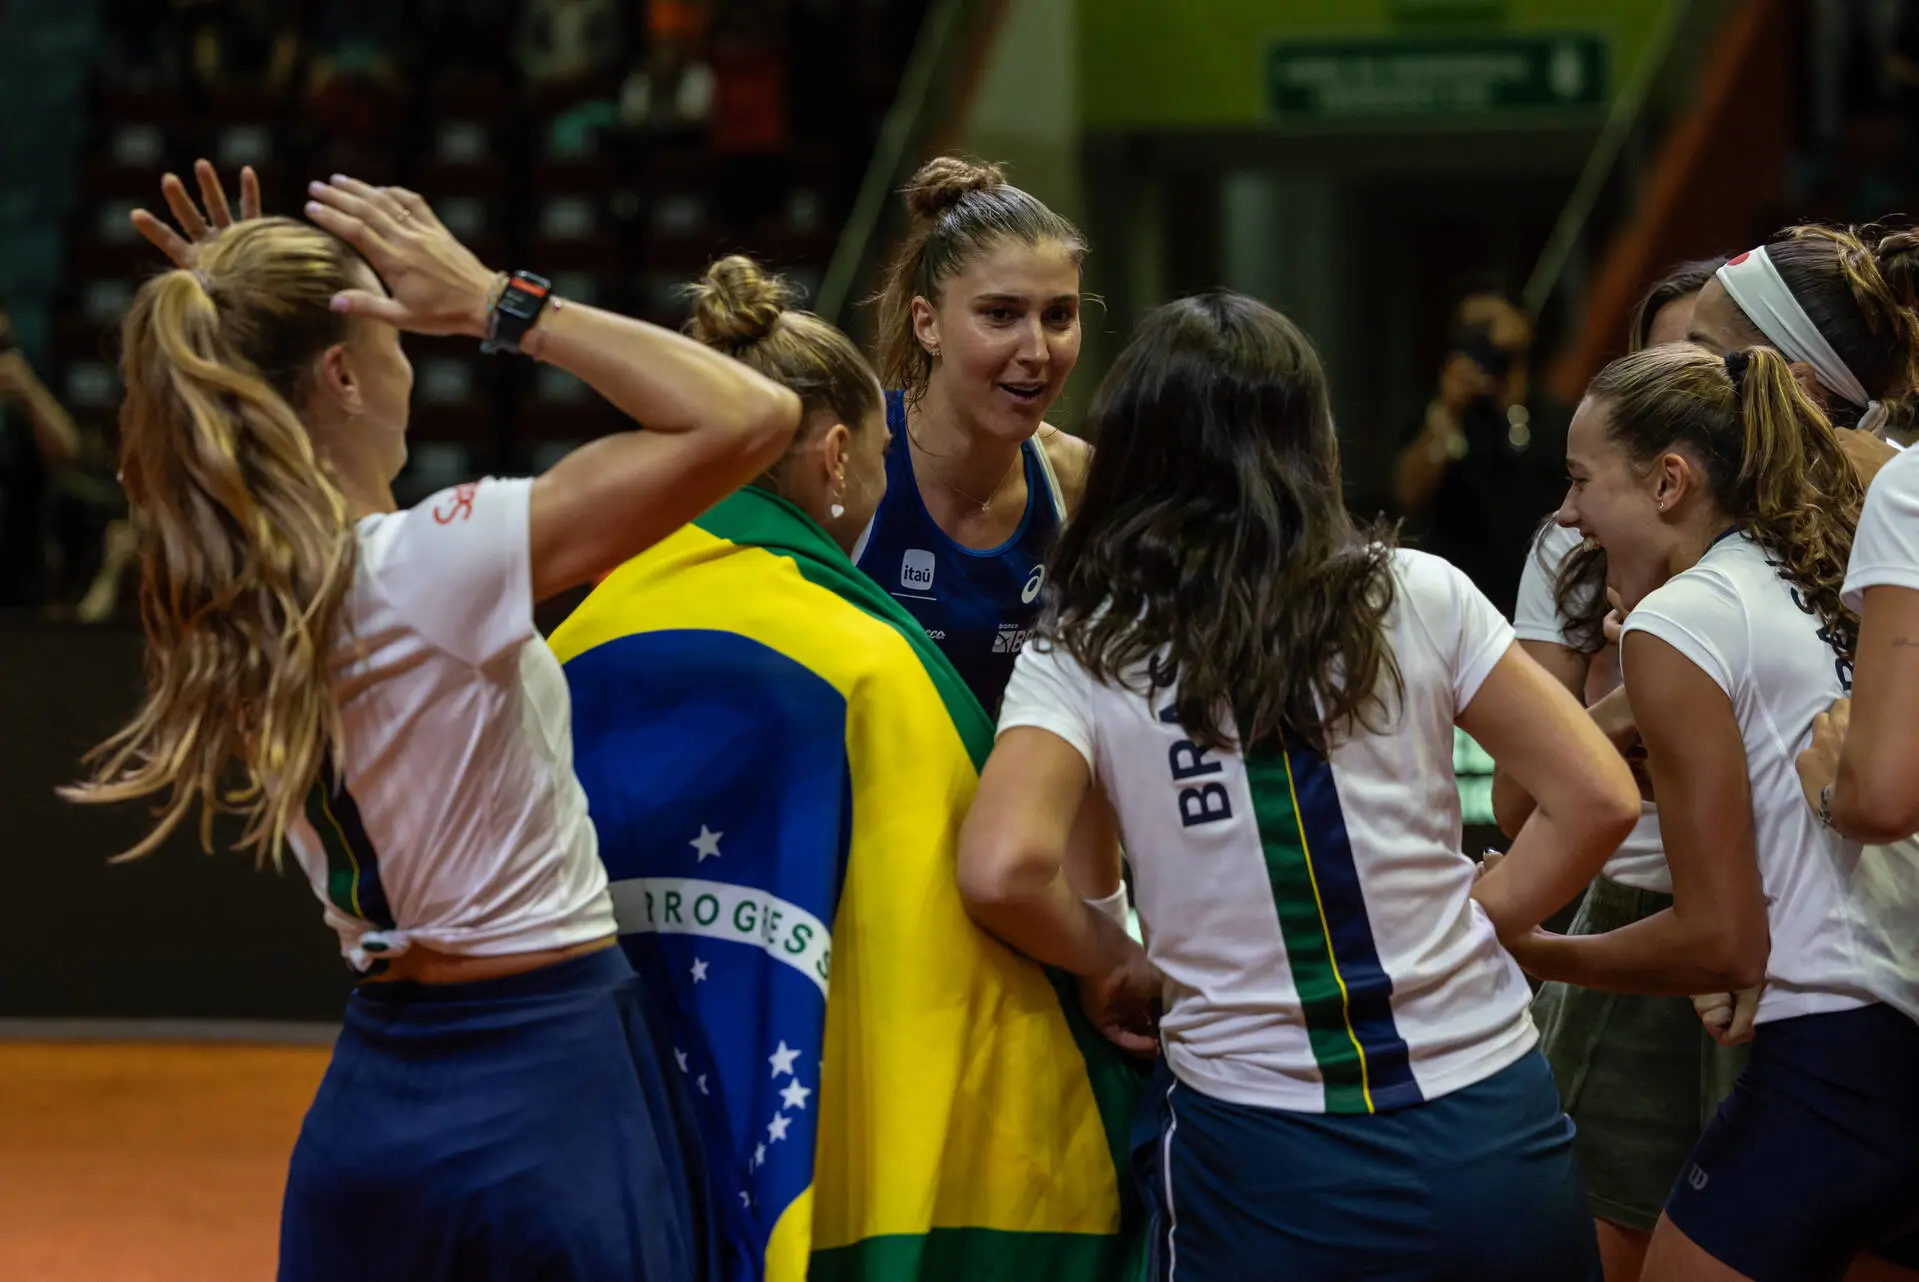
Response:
[1587,344,1865,660]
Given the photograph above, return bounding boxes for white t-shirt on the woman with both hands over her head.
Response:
[290,480,614,969]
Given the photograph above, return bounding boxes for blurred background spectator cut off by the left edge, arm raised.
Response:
[0,299,81,608]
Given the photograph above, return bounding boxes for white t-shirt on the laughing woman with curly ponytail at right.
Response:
[1625,535,1919,1023]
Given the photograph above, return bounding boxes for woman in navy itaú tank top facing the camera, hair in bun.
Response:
[854,157,1088,716]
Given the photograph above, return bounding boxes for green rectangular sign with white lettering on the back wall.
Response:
[1267,33,1610,119]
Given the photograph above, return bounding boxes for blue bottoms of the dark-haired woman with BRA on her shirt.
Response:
[1138,1052,1600,1282]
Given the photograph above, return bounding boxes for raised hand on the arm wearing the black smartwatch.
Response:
[307,175,495,338]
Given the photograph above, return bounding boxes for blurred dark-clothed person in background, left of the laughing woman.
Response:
[1393,292,1566,618]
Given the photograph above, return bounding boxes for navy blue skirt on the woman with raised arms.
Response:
[280,948,716,1282]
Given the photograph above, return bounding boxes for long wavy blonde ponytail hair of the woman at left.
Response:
[61,219,359,860]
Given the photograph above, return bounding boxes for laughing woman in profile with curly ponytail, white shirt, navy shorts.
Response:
[1508,345,1919,1282]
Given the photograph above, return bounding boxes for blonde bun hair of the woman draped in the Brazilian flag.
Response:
[685,253,881,491]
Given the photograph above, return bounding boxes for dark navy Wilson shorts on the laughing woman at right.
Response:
[1666,1006,1919,1282]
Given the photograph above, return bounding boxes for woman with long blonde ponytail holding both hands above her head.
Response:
[69,169,798,1282]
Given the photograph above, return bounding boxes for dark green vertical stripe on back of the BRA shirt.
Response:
[1245,747,1372,1113]
